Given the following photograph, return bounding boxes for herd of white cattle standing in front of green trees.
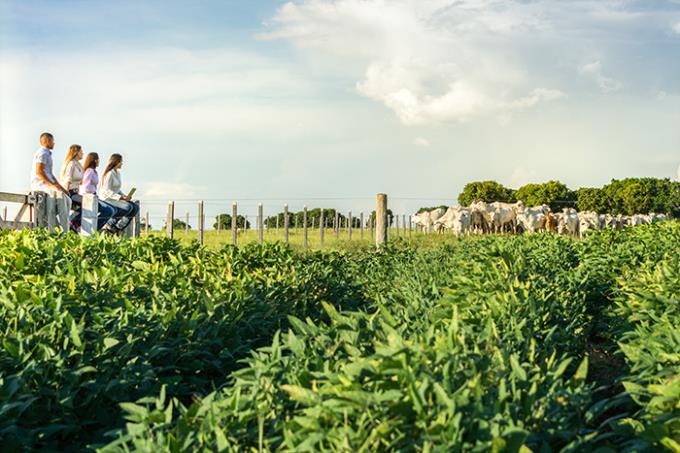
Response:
[411,201,667,237]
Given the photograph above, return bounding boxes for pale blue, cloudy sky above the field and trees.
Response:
[0,0,680,226]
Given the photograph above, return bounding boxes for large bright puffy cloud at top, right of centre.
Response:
[260,0,564,125]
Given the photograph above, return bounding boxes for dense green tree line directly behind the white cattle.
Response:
[458,178,680,217]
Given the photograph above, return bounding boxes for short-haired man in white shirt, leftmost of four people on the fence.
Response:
[31,132,71,229]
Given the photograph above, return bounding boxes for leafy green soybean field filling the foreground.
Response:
[0,220,680,452]
